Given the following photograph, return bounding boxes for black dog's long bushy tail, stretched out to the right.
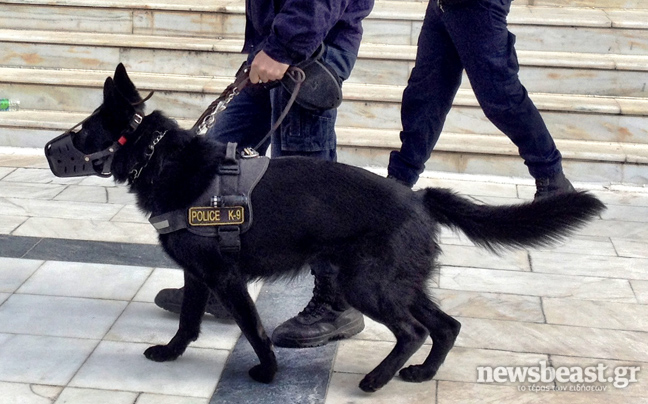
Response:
[418,188,605,251]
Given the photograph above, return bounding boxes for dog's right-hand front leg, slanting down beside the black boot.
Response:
[213,264,277,383]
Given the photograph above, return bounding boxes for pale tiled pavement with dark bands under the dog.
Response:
[0,149,648,404]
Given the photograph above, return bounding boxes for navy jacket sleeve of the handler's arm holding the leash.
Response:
[263,0,353,64]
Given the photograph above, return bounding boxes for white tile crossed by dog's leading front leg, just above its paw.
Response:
[105,302,241,349]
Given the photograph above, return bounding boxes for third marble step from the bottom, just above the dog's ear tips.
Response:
[0,29,648,97]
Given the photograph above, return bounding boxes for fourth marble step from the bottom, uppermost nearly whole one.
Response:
[0,0,648,54]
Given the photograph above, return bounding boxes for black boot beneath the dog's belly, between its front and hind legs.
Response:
[272,298,364,348]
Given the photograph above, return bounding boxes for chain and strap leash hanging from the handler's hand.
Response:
[191,63,306,153]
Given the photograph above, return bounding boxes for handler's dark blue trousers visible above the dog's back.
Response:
[207,46,356,161]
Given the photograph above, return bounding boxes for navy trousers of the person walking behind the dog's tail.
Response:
[388,0,562,185]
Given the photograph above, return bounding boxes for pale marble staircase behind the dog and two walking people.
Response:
[0,0,648,184]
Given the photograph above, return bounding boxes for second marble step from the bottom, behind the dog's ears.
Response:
[0,68,648,144]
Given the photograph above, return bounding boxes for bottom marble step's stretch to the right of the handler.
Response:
[337,127,648,185]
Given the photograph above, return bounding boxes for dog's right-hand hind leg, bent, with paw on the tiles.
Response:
[400,291,461,382]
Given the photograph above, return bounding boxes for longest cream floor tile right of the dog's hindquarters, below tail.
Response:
[440,267,635,303]
